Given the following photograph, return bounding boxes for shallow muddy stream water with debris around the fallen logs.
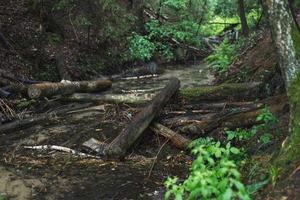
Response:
[0,61,213,199]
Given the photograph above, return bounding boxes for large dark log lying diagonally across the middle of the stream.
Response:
[103,78,180,158]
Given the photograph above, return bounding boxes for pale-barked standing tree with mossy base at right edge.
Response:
[262,0,300,172]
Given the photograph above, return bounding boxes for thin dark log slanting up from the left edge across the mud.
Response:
[0,104,91,134]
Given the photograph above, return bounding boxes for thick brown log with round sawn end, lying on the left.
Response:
[28,80,112,99]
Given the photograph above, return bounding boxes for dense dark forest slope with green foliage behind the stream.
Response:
[1,0,270,80]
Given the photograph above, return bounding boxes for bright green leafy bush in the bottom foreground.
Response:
[165,138,250,200]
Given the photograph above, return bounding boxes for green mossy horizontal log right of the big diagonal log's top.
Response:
[179,82,262,102]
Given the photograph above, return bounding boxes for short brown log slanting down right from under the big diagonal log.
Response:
[150,123,192,149]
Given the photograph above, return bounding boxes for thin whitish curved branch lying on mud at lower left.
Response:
[24,145,100,159]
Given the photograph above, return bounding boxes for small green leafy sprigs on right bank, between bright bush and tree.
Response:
[225,107,278,144]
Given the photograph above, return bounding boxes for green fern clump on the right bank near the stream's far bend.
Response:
[206,38,237,73]
